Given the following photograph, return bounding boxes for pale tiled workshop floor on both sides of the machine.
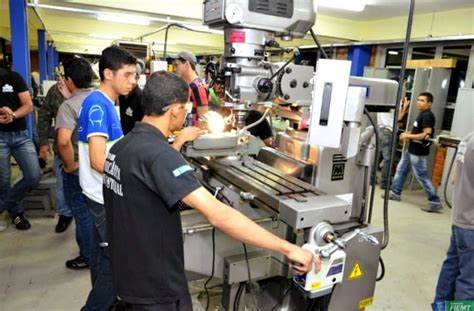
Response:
[0,188,450,311]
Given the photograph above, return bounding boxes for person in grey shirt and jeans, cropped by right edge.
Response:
[432,132,474,311]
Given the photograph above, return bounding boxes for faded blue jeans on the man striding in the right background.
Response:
[390,151,440,203]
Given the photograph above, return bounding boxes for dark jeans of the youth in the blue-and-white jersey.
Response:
[82,198,117,311]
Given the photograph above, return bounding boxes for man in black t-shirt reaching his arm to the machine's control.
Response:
[103,71,319,311]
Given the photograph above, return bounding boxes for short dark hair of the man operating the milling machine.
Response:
[142,71,189,116]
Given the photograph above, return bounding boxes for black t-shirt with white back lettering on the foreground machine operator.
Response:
[104,122,201,304]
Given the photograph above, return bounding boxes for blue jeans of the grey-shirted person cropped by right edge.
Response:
[432,225,474,310]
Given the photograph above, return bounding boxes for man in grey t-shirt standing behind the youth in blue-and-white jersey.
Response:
[55,57,93,270]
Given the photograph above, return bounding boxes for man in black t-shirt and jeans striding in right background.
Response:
[390,92,442,212]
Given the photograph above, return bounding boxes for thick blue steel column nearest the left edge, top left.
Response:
[9,0,33,138]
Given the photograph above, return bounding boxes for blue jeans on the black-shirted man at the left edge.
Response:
[0,130,41,215]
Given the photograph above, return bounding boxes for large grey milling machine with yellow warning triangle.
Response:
[181,0,398,311]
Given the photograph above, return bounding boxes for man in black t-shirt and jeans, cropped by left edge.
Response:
[0,68,41,230]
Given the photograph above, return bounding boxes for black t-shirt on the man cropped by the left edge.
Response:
[0,68,28,132]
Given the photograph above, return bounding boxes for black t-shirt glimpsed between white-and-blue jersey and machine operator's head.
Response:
[119,86,143,135]
